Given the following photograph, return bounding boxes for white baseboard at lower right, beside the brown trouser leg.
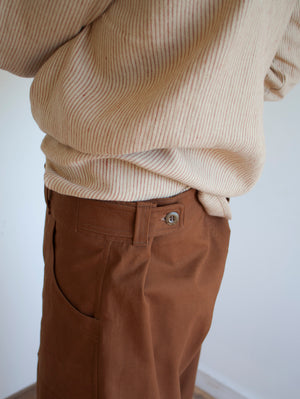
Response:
[196,369,250,399]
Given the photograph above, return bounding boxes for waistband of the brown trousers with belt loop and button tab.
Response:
[45,186,205,246]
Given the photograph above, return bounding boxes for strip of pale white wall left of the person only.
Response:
[0,71,45,399]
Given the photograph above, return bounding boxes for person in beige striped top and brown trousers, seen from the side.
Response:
[0,0,300,399]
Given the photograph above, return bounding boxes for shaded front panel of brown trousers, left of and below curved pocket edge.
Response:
[37,214,99,399]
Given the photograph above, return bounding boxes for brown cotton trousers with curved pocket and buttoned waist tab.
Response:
[37,187,230,399]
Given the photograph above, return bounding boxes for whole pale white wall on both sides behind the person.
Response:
[0,71,300,399]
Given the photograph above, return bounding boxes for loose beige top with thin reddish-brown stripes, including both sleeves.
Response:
[0,0,300,219]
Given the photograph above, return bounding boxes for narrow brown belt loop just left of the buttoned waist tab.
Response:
[132,201,156,247]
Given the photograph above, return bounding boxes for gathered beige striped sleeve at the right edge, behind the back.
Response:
[264,0,300,101]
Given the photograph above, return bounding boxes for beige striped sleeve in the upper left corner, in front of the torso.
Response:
[0,0,113,77]
